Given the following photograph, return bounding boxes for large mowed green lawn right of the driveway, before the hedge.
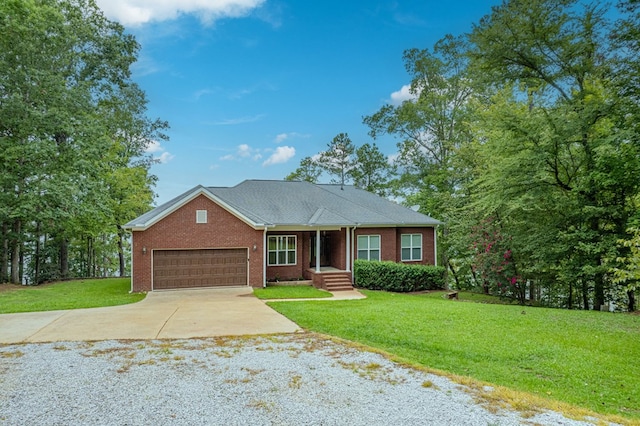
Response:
[269,291,640,422]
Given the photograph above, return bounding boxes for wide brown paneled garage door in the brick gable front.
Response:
[153,249,247,290]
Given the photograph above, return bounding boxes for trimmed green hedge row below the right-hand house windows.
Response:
[353,260,445,293]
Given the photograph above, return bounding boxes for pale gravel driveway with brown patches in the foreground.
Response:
[0,333,608,426]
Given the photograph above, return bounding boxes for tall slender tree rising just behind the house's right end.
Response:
[364,36,478,281]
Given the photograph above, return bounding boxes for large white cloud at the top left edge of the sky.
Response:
[97,0,265,26]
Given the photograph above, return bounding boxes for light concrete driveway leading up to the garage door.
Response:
[0,287,300,343]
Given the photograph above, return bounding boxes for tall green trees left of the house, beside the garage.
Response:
[0,0,168,284]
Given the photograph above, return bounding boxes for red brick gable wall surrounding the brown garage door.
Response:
[132,195,264,292]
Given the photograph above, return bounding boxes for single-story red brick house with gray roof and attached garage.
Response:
[124,180,440,292]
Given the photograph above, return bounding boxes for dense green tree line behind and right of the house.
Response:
[287,0,640,311]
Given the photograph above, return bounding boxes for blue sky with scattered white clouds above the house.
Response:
[97,0,501,204]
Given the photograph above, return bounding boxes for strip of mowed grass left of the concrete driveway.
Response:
[0,278,145,314]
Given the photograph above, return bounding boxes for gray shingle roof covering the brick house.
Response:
[125,180,440,228]
